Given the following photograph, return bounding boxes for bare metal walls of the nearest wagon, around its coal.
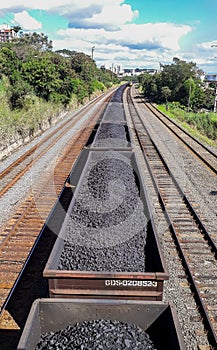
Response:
[17,299,185,350]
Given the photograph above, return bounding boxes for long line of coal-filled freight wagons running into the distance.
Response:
[18,84,184,350]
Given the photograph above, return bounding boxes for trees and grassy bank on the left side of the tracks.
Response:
[0,33,118,148]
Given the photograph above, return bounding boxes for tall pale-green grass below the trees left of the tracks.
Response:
[0,76,107,150]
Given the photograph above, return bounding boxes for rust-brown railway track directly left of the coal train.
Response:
[0,96,110,324]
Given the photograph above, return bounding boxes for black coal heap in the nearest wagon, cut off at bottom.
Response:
[36,319,156,350]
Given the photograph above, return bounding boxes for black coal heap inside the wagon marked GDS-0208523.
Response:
[58,151,147,272]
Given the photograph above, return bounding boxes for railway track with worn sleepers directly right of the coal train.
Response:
[127,87,217,346]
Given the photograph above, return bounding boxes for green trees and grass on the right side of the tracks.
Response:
[139,58,217,142]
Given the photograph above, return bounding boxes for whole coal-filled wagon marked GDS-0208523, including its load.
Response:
[44,150,168,300]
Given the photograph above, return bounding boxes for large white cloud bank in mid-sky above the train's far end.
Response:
[53,23,191,68]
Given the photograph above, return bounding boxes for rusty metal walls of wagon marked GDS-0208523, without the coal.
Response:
[43,150,169,300]
